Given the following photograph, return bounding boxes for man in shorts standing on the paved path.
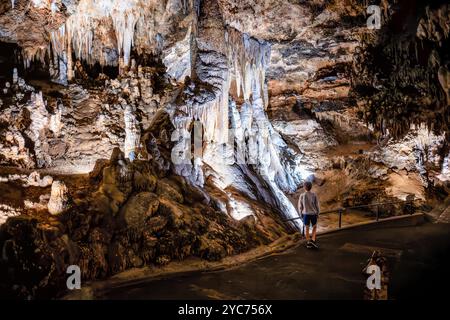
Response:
[298,181,319,249]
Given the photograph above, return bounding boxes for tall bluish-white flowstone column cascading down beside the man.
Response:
[172,23,304,225]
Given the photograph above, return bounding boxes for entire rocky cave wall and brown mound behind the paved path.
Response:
[0,0,450,298]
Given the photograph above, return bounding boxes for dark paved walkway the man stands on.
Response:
[95,222,450,300]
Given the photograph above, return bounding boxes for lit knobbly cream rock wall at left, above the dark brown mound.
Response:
[0,66,165,173]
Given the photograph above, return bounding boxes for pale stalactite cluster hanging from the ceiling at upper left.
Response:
[51,0,199,79]
